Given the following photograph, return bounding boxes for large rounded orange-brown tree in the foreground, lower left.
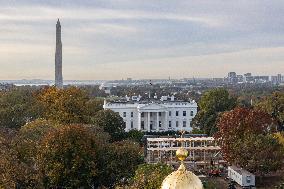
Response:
[38,125,99,188]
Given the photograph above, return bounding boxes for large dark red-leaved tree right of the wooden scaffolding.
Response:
[215,108,283,174]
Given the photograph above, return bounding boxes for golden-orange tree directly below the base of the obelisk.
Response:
[38,87,89,124]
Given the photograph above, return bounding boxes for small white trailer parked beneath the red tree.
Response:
[228,166,255,187]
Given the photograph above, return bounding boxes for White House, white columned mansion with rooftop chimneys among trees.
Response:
[103,96,197,132]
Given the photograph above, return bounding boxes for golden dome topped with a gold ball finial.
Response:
[161,148,203,189]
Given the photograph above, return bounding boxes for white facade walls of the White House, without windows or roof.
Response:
[104,102,197,131]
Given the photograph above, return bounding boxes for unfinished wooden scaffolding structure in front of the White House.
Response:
[145,137,226,168]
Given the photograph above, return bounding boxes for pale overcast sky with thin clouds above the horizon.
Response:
[0,0,284,80]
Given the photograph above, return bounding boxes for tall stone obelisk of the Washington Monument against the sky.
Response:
[55,19,63,89]
